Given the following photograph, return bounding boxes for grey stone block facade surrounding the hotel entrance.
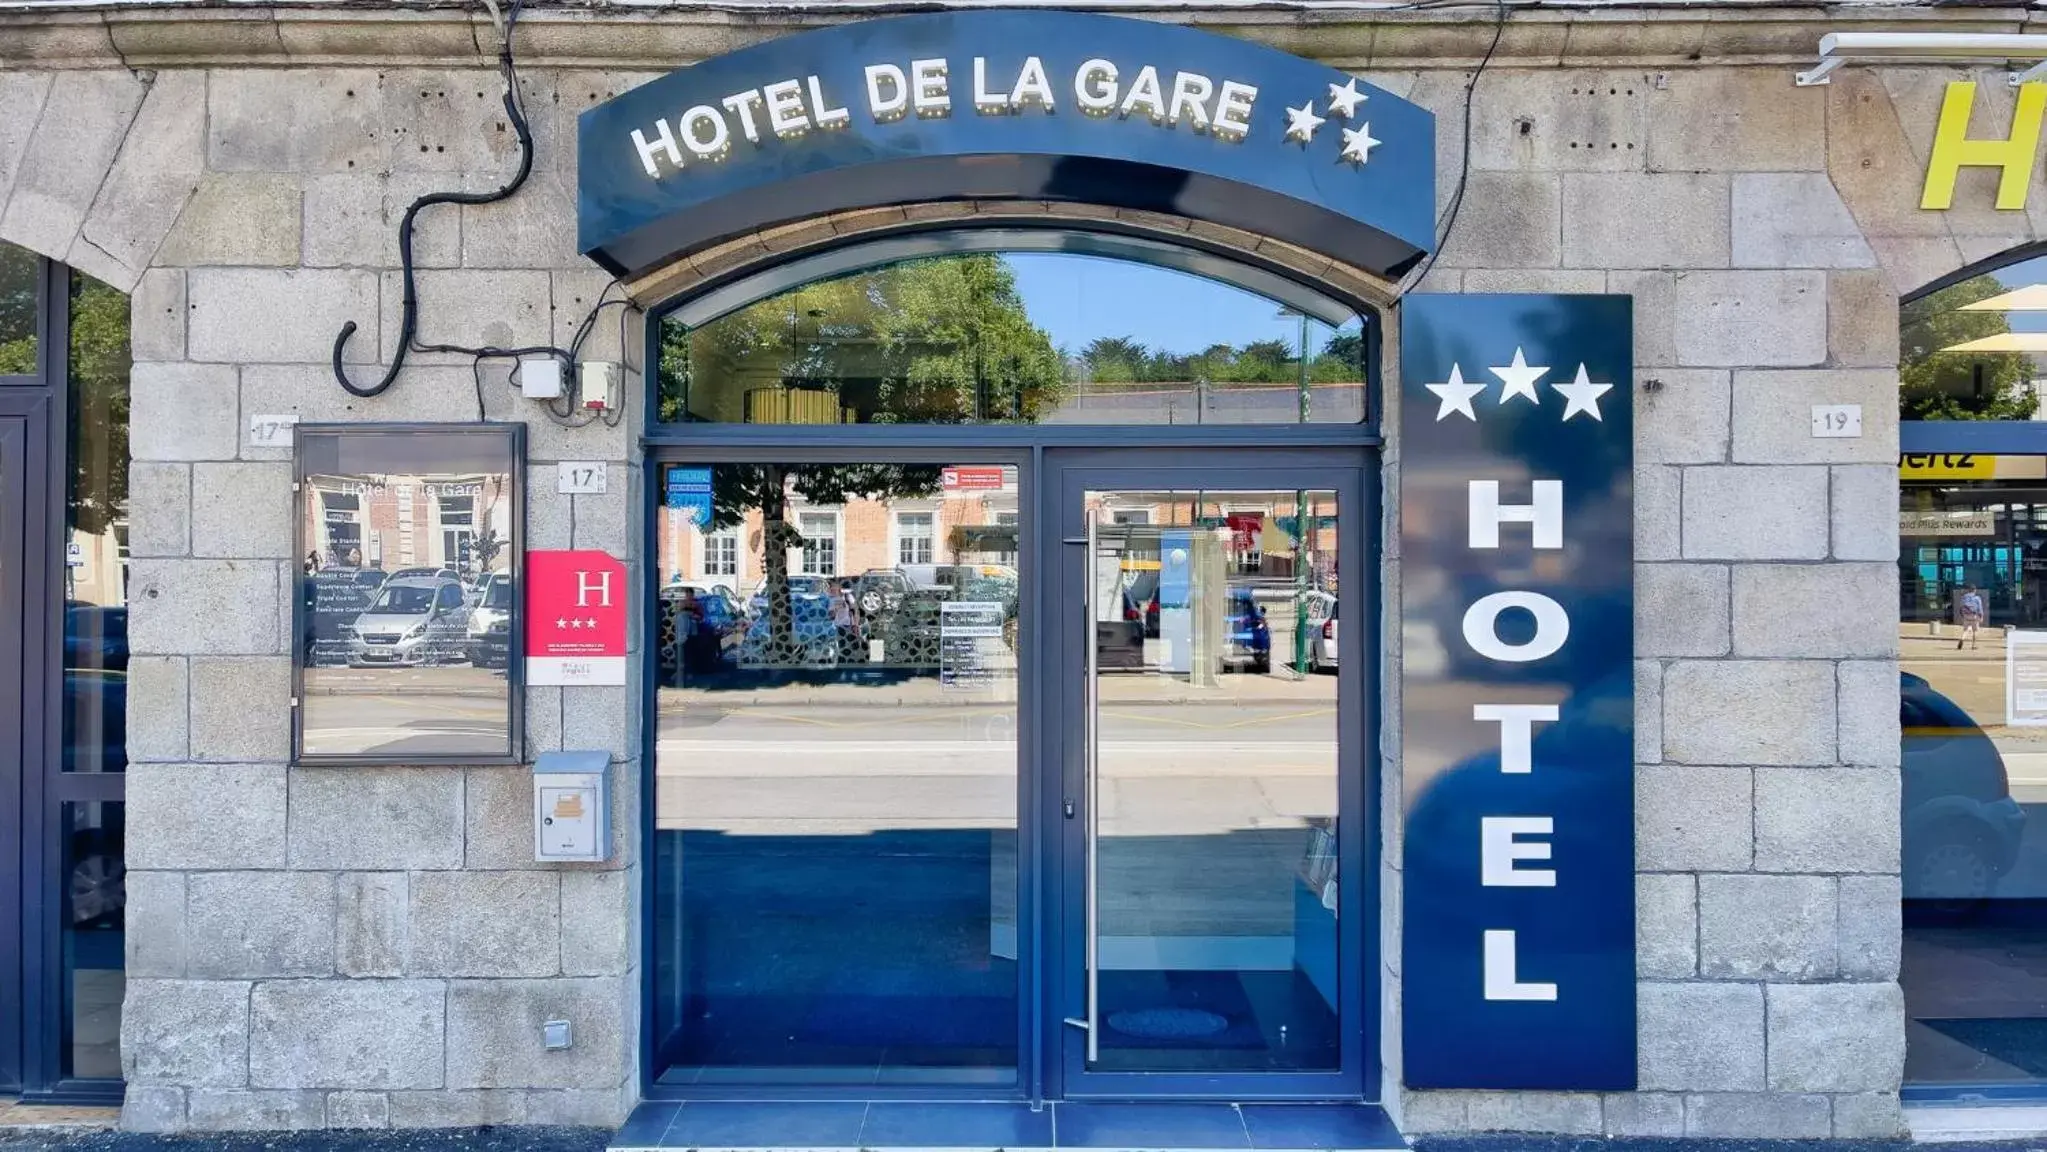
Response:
[0,0,2014,1138]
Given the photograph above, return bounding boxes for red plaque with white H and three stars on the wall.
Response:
[526,550,626,685]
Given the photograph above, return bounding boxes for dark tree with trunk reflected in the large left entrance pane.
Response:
[698,464,940,651]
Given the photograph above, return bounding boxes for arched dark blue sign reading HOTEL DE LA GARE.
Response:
[577,10,1435,276]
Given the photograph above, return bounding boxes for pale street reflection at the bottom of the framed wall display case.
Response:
[305,667,510,755]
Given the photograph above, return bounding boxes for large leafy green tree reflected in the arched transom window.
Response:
[661,254,1060,424]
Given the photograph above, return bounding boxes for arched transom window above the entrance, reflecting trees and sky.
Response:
[657,252,1365,424]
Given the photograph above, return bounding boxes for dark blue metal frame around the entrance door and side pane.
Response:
[641,444,1382,1101]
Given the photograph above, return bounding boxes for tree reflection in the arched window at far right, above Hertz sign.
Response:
[1898,276,2039,419]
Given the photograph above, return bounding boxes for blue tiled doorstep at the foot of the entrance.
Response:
[612,1101,1406,1152]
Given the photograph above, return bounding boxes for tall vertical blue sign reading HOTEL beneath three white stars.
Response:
[1400,295,1636,1091]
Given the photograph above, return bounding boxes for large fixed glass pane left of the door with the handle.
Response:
[653,464,1024,1084]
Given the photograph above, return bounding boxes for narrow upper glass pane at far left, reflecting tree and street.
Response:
[63,272,129,771]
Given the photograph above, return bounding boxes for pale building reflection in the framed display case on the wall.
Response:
[301,475,512,575]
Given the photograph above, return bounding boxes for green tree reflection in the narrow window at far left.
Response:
[70,272,129,536]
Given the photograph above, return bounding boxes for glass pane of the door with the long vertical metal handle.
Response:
[1087,491,1341,1072]
